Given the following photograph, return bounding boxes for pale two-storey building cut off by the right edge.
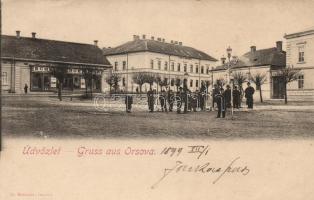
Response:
[284,27,314,101]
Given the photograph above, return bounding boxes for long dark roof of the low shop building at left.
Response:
[1,35,110,66]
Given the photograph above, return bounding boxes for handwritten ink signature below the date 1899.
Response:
[151,157,250,189]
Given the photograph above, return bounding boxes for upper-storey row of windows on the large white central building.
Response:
[114,60,210,74]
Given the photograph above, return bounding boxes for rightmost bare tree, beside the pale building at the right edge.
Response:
[278,65,301,104]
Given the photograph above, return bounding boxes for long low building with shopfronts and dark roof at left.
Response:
[1,31,111,93]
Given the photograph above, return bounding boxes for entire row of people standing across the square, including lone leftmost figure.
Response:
[125,82,255,118]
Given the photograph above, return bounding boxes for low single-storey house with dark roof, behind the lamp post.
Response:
[212,41,286,101]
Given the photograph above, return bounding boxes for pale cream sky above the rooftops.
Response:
[2,0,314,59]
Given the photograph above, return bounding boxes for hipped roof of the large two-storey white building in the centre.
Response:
[103,39,217,61]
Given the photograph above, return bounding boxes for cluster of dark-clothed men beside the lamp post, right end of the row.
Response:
[213,82,255,118]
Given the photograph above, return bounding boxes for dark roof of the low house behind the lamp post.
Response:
[214,47,286,70]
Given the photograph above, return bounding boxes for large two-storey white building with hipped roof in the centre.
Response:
[104,35,217,92]
